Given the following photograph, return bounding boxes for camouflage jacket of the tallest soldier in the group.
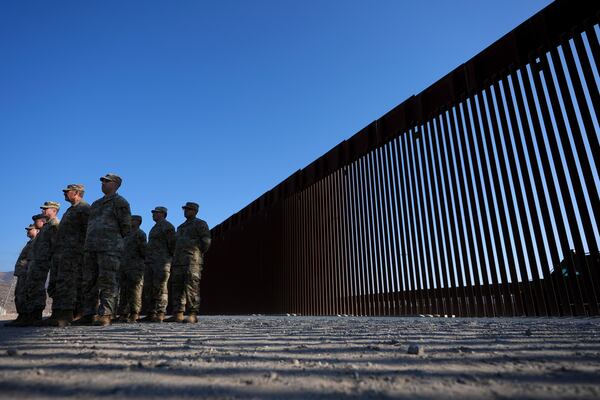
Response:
[84,193,131,253]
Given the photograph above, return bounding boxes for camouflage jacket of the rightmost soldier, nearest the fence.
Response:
[173,218,211,265]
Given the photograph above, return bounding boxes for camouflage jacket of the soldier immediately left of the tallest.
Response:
[56,200,90,255]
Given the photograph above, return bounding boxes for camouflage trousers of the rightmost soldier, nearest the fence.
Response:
[171,263,202,314]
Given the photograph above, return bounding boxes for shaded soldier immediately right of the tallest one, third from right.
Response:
[119,215,146,323]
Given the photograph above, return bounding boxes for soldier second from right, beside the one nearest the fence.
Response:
[142,206,175,322]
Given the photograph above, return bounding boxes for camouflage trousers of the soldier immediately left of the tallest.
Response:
[52,254,83,311]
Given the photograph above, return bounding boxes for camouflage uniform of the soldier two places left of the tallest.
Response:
[25,218,59,313]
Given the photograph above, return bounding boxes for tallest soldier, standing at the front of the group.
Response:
[74,174,131,326]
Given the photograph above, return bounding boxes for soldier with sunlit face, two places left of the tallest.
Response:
[15,201,60,326]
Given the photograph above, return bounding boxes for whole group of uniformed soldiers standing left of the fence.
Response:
[6,174,211,327]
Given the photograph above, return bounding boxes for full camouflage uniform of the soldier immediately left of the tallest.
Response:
[52,200,90,310]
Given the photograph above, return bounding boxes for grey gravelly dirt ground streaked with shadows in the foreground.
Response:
[0,316,600,399]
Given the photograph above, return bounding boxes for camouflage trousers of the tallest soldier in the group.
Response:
[82,251,121,315]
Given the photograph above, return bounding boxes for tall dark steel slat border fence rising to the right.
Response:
[201,1,600,316]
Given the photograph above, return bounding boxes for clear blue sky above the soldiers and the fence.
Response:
[0,0,549,271]
